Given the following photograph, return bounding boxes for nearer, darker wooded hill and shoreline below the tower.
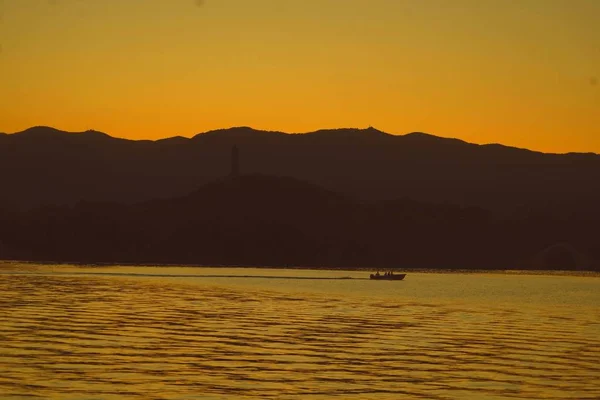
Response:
[0,174,600,270]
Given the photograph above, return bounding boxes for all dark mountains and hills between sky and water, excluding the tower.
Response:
[0,127,600,270]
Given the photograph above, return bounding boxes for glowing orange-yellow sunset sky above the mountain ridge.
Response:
[0,0,600,153]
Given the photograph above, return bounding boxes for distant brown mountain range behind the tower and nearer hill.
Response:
[0,127,600,216]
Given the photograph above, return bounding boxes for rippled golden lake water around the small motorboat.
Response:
[0,262,600,400]
